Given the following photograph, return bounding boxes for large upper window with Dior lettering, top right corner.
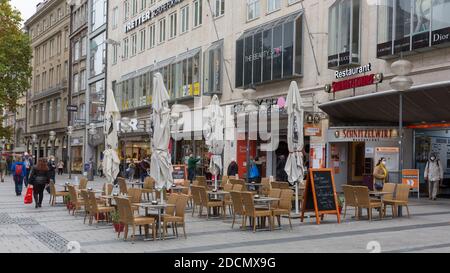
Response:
[377,0,450,58]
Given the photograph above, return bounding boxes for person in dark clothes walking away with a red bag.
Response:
[29,158,54,208]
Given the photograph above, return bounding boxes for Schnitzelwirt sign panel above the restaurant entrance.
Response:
[328,127,398,142]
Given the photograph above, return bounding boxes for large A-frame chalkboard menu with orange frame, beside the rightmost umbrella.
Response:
[302,169,340,224]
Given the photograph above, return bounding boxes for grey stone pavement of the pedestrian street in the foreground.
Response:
[0,175,450,253]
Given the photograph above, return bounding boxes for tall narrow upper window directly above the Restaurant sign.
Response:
[328,0,361,68]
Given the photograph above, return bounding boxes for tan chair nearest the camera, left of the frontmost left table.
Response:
[115,197,156,241]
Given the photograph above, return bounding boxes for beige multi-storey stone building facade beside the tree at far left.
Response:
[25,0,70,162]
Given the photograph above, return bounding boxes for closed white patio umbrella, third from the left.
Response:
[205,95,224,189]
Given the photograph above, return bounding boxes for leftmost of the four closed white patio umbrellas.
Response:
[103,89,120,183]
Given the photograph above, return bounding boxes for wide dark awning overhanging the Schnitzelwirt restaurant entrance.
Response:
[319,81,450,124]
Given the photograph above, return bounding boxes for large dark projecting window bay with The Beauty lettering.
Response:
[235,13,302,88]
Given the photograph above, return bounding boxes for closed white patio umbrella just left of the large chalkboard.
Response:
[284,81,305,214]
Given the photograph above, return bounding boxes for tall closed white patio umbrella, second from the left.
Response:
[150,73,173,196]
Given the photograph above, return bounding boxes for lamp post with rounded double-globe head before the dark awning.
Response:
[390,60,413,215]
